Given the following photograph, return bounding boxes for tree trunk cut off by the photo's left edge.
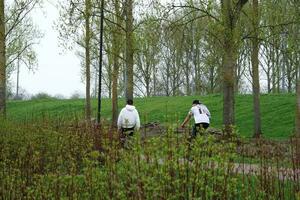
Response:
[0,0,6,118]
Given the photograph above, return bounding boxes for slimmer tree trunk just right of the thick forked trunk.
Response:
[251,0,261,137]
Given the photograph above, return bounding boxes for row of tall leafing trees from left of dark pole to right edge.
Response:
[0,0,300,136]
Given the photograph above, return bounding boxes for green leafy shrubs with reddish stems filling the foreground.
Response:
[0,122,296,199]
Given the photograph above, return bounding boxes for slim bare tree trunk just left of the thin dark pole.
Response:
[85,0,91,125]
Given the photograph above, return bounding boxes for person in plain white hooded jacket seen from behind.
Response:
[118,99,141,136]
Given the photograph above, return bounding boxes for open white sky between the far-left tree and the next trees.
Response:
[11,0,85,97]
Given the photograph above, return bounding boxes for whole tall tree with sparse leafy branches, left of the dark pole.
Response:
[57,0,97,125]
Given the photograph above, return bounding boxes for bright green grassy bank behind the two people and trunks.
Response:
[7,94,296,139]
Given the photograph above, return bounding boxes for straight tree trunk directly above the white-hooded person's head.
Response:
[125,0,133,99]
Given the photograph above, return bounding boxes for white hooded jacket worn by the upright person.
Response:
[118,105,141,130]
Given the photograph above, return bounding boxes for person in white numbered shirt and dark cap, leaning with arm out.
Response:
[181,100,210,137]
